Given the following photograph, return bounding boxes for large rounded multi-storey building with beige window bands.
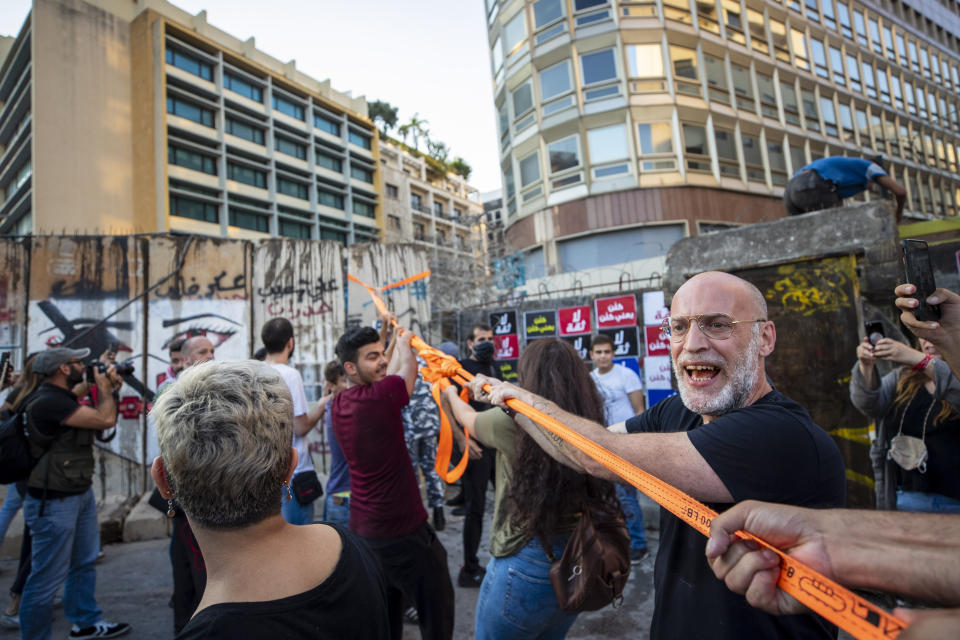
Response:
[486,0,960,286]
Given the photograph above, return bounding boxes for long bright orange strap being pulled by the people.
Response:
[347,271,906,640]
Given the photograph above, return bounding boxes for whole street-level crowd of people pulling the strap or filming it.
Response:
[0,272,960,639]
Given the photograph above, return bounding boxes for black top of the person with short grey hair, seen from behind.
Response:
[177,524,390,640]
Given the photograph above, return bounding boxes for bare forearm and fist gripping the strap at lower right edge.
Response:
[706,500,960,614]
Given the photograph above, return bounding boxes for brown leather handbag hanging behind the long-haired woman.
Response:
[543,503,630,611]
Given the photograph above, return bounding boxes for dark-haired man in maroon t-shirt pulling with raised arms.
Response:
[331,327,454,640]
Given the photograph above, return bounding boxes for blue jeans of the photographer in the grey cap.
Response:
[20,489,101,640]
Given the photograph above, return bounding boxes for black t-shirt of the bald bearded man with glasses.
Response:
[626,391,846,640]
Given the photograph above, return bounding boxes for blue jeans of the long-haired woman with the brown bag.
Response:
[473,534,577,640]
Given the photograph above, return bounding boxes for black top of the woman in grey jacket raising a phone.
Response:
[887,387,960,500]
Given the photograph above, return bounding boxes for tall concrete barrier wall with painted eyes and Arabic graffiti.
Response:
[0,235,430,500]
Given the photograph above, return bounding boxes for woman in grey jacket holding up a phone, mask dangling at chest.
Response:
[850,333,960,513]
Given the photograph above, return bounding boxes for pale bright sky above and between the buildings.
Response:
[0,0,500,193]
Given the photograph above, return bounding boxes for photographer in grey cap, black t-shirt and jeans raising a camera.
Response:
[20,348,130,640]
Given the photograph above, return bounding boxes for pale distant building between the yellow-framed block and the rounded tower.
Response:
[380,139,487,309]
